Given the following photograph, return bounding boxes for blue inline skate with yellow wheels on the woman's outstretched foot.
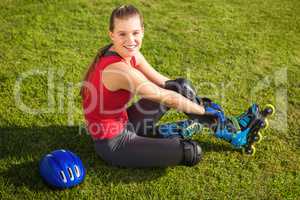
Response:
[191,98,275,155]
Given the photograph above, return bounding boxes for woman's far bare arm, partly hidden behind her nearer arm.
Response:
[135,52,169,87]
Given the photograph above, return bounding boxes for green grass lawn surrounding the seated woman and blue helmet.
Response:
[0,0,300,199]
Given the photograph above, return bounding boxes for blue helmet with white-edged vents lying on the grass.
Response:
[40,149,85,188]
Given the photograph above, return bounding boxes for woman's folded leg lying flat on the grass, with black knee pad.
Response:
[95,126,202,167]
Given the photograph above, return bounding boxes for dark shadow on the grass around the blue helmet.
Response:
[0,126,234,192]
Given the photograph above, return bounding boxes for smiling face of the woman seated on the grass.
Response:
[109,16,144,58]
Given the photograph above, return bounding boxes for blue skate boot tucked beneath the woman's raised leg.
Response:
[155,120,203,139]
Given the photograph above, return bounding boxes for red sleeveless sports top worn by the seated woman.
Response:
[83,51,136,139]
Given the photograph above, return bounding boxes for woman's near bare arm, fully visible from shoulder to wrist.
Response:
[102,62,205,115]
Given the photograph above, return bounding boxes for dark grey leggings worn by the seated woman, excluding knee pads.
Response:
[95,99,201,167]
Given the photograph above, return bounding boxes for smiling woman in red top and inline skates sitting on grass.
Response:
[78,5,274,167]
